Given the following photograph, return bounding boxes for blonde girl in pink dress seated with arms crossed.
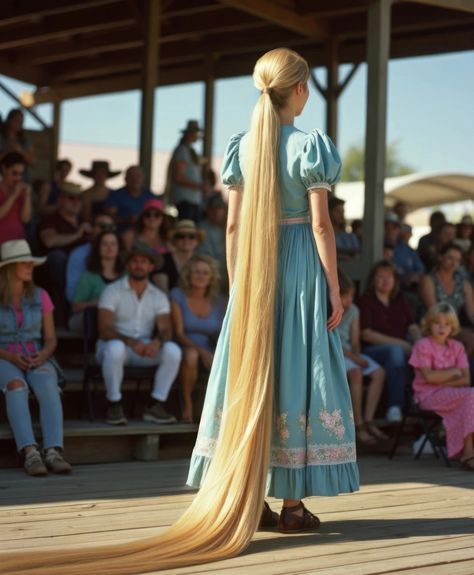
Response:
[410,303,474,471]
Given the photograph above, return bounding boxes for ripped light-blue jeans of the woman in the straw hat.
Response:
[0,359,63,451]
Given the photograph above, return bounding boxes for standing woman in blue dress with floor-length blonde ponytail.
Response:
[2,48,358,575]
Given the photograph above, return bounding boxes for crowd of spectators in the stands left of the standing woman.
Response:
[0,115,227,475]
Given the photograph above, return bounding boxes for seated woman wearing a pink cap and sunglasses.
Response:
[122,199,168,254]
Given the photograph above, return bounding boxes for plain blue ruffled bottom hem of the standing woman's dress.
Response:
[186,455,359,499]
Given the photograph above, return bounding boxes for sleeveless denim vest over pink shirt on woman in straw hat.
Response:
[0,287,43,350]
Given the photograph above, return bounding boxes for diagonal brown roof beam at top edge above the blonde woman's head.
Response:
[221,0,329,41]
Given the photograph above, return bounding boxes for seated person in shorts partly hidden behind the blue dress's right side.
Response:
[337,273,388,445]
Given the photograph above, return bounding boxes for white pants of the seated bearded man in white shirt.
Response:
[96,339,182,401]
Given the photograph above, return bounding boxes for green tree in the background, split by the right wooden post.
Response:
[341,141,416,182]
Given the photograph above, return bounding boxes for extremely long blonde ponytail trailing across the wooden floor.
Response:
[2,48,309,575]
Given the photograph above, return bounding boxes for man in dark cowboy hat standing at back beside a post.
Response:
[168,120,211,222]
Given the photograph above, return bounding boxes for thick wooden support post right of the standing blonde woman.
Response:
[362,0,391,281]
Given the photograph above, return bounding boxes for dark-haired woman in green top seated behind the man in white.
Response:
[69,231,124,333]
